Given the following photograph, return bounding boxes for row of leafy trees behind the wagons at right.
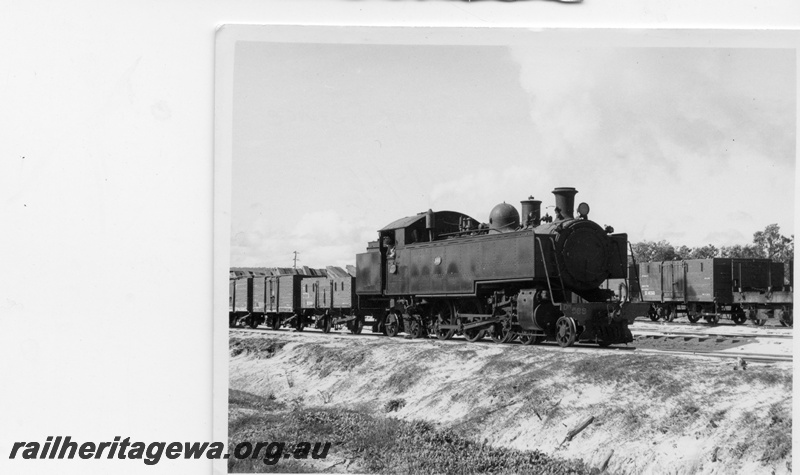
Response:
[632,224,794,277]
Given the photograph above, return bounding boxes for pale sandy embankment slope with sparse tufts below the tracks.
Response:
[230,332,792,474]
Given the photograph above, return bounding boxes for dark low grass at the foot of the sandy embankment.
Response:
[228,390,599,474]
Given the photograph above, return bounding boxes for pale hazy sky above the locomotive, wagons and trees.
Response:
[231,42,797,267]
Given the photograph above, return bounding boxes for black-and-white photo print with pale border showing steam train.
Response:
[215,25,800,474]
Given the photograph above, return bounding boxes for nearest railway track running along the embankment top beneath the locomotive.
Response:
[230,328,793,363]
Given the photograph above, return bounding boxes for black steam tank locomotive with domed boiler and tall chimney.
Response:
[356,188,647,347]
